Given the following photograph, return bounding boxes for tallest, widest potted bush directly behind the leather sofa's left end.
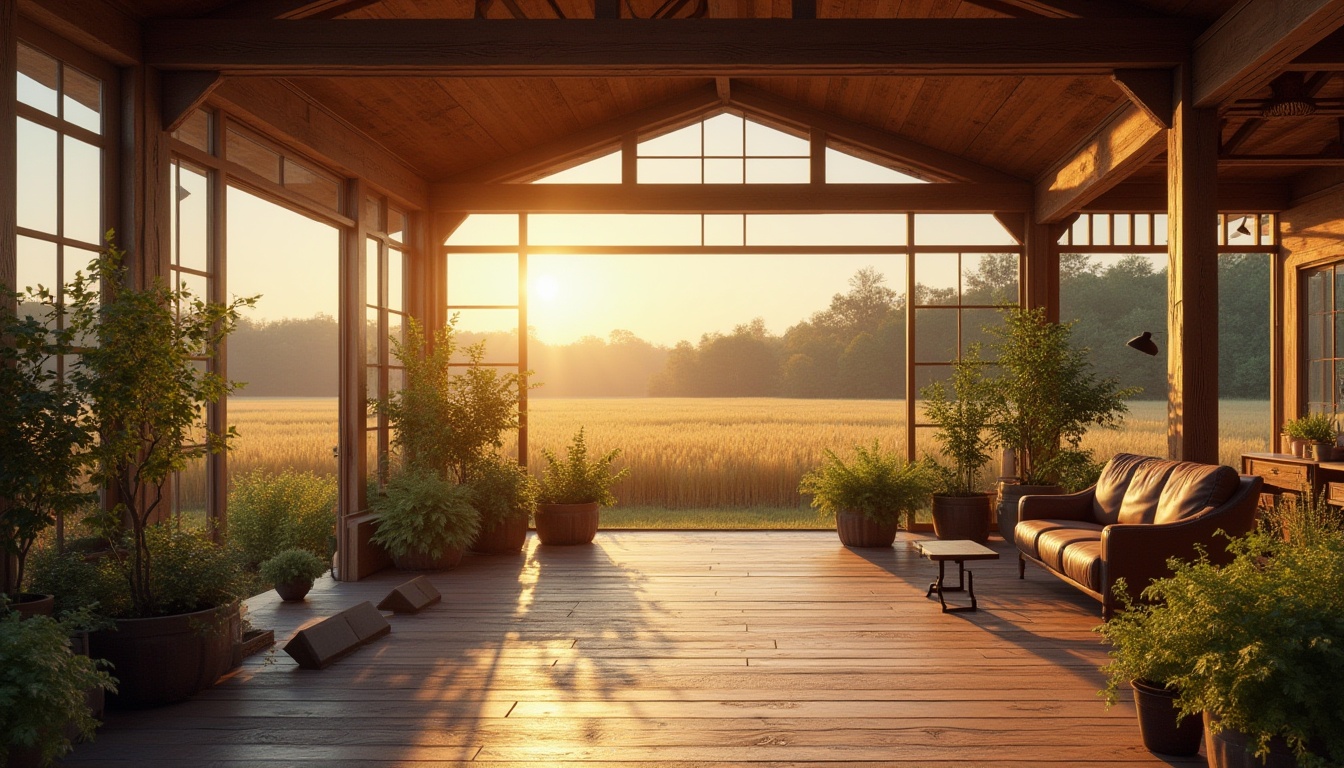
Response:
[984,308,1140,541]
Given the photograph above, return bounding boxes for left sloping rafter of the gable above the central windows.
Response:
[450,86,723,182]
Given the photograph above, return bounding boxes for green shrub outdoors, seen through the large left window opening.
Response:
[227,469,337,568]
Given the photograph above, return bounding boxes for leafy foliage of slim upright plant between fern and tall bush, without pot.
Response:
[919,344,995,496]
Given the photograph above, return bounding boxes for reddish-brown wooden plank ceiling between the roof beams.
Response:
[104,0,1344,204]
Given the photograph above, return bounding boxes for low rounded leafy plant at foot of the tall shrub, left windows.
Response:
[370,468,481,558]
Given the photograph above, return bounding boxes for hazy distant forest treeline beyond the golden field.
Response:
[220,254,1269,399]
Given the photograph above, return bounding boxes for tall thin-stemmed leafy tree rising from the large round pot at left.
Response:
[67,233,255,616]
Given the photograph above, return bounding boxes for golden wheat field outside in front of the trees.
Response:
[228,398,1269,527]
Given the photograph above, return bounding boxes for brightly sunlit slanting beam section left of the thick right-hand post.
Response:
[1036,104,1164,222]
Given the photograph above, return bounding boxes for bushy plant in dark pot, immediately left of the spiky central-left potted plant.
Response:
[468,455,538,554]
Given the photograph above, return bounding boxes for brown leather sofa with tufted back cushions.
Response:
[1013,453,1263,619]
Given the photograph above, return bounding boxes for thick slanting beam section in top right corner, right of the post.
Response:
[1191,0,1344,108]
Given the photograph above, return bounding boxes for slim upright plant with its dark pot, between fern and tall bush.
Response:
[919,344,993,543]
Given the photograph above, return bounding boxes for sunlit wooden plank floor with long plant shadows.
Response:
[66,531,1203,768]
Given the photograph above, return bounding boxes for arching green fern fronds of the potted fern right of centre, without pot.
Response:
[798,441,935,523]
